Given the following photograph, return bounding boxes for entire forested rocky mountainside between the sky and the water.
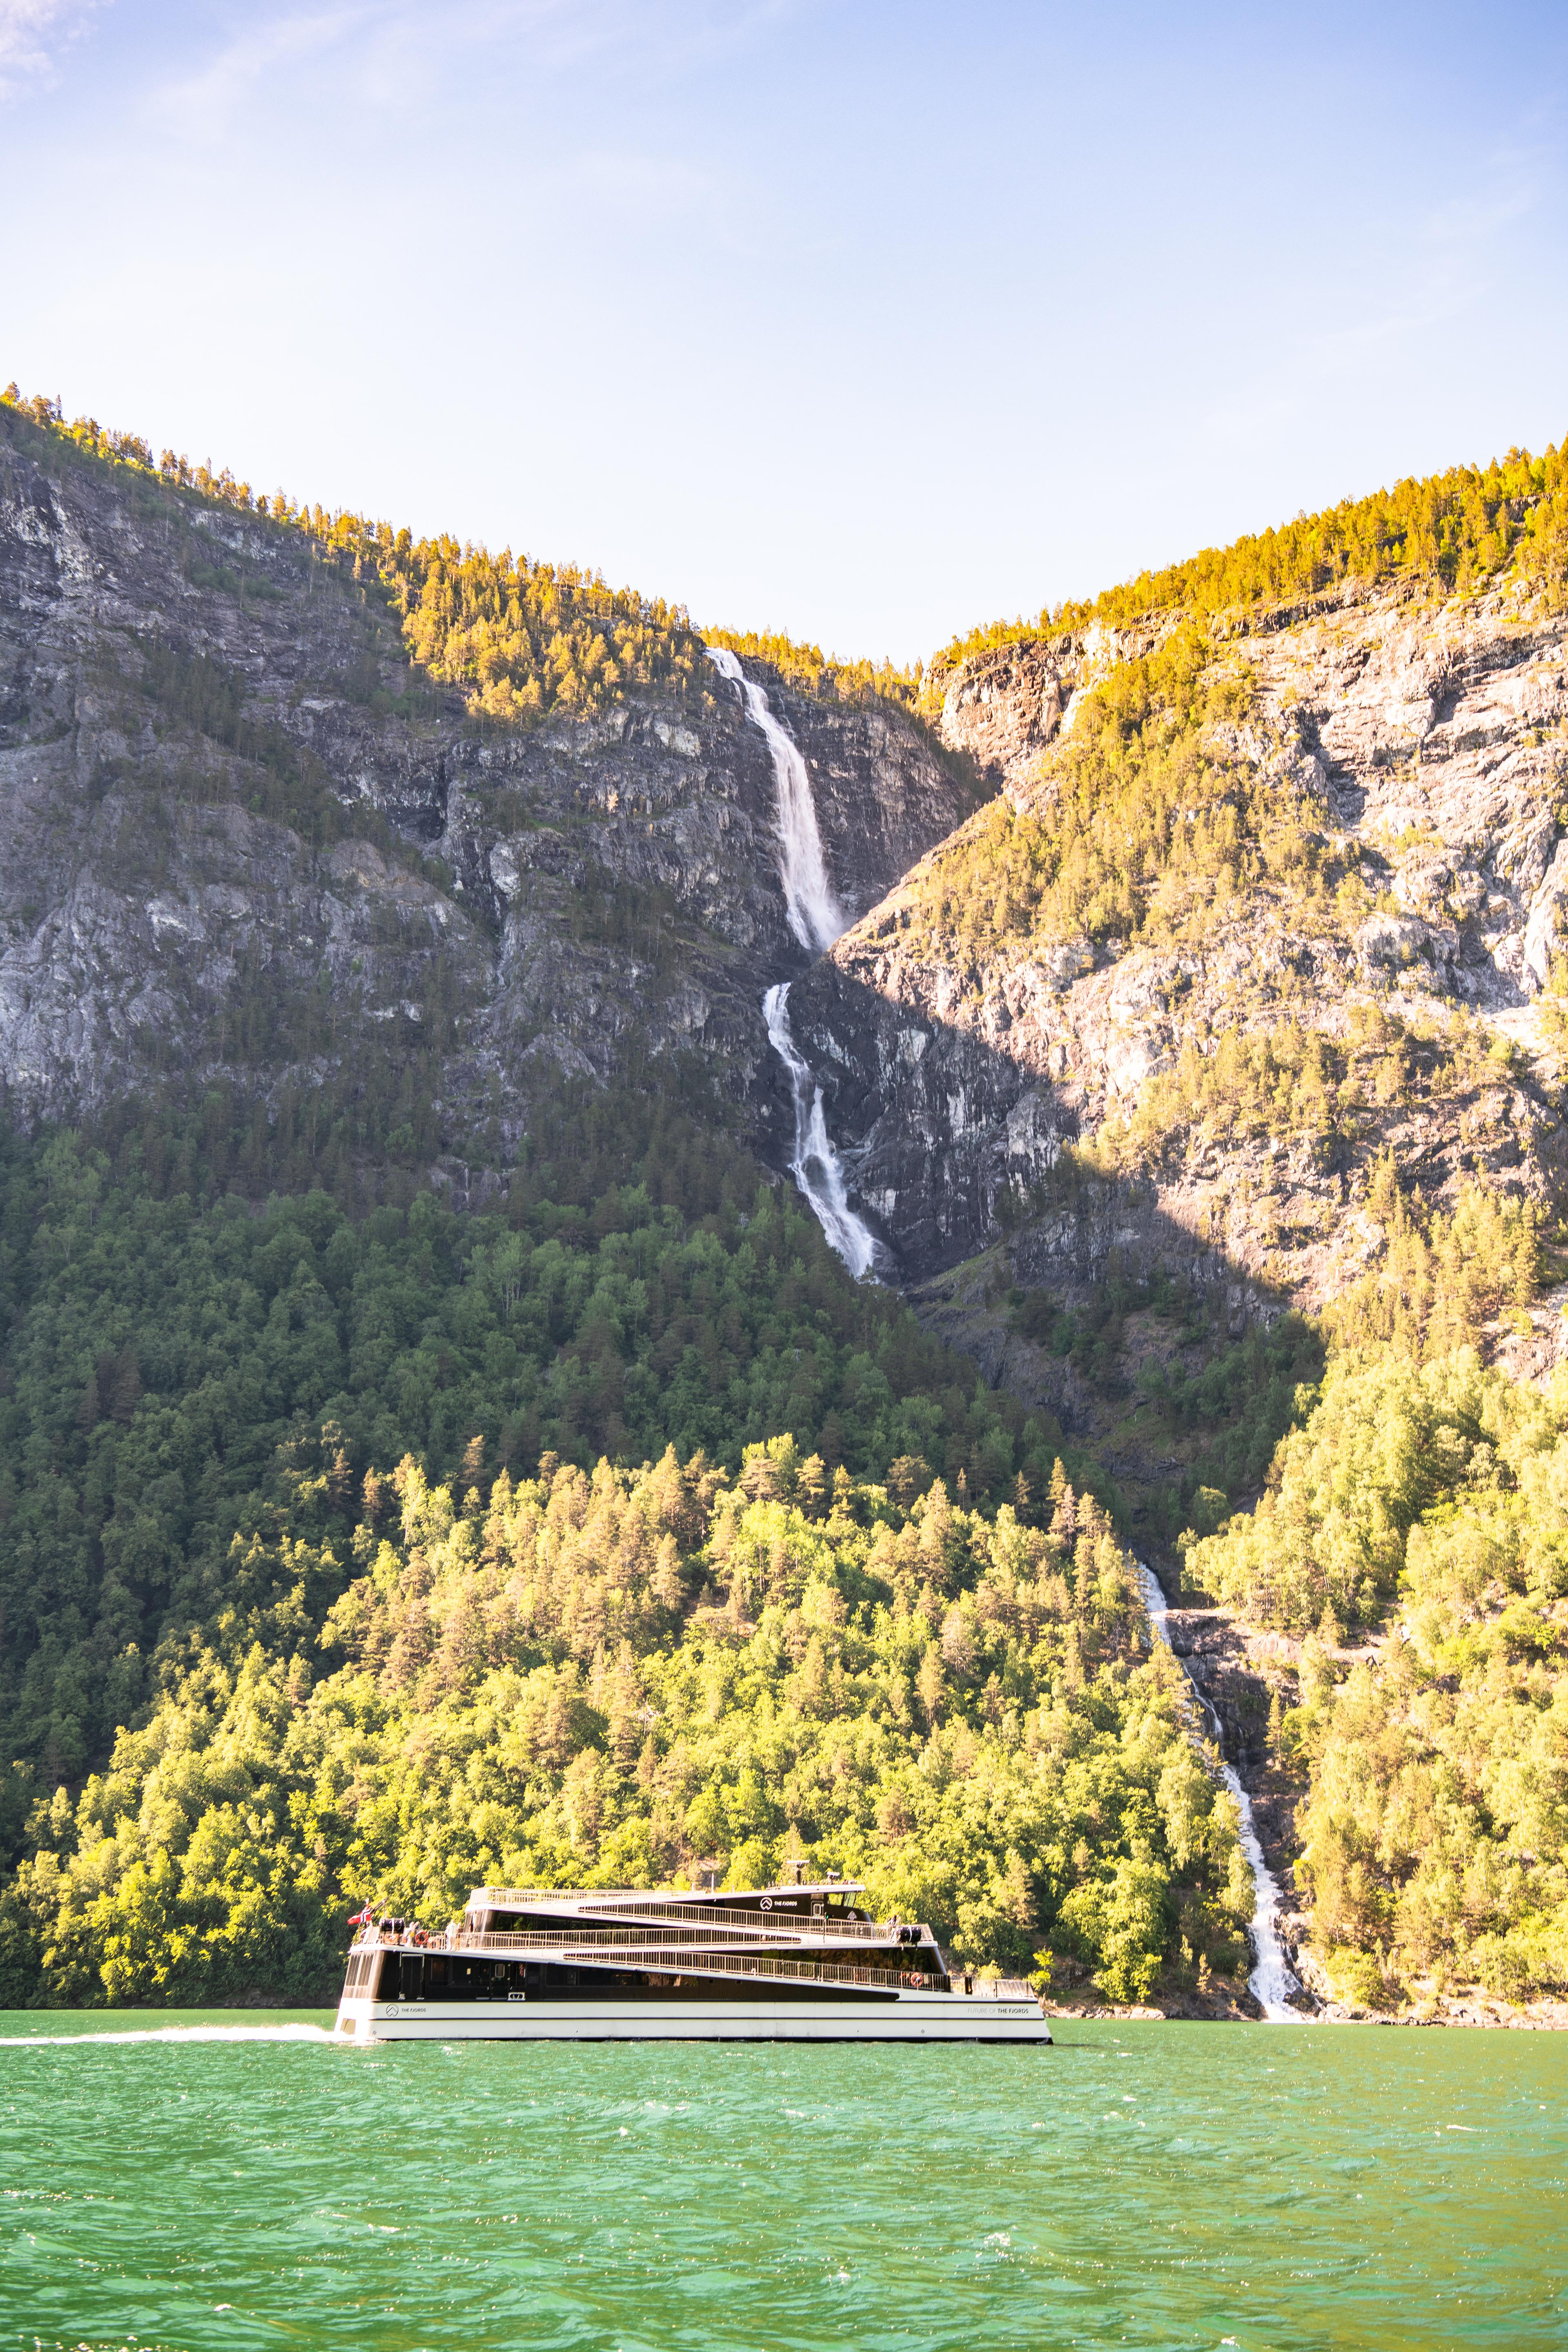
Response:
[0,388,1568,2016]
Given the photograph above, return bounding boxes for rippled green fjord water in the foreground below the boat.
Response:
[0,2013,1568,2352]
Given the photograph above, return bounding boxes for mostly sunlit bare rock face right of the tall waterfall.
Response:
[790,578,1568,1322]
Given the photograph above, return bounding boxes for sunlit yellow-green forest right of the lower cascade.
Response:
[1187,1348,1568,2009]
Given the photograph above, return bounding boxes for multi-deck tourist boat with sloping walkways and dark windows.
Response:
[336,1879,1051,2042]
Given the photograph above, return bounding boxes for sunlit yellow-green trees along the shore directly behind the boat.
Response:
[0,1435,1253,2004]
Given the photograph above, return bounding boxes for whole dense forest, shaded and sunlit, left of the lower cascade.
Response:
[0,1120,1203,1999]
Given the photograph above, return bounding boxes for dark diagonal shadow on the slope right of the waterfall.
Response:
[757,962,1321,1552]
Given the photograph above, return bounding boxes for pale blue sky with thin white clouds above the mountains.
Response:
[0,0,1568,663]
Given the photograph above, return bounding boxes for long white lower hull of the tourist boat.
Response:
[339,1992,1051,2044]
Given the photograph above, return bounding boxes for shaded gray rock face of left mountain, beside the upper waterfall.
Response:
[0,423,973,1145]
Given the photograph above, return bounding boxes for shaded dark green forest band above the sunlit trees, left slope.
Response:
[0,1120,1060,1778]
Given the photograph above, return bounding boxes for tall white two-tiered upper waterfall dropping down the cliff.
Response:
[708,644,886,1282]
